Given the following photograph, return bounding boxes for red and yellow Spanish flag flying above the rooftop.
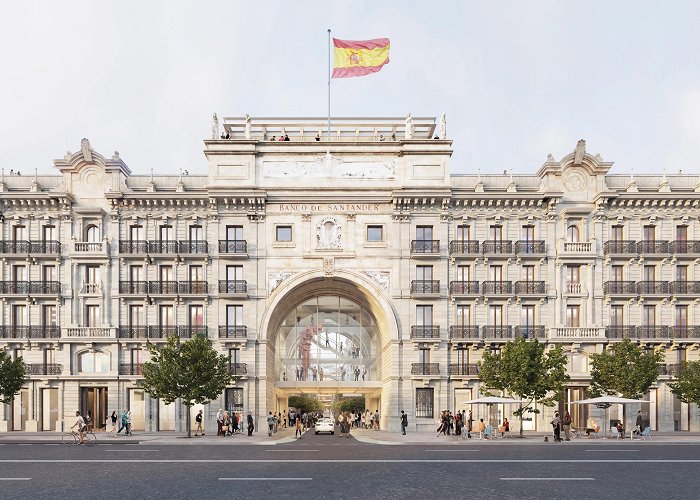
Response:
[333,38,389,78]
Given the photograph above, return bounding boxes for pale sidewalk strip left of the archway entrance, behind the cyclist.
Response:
[0,428,306,446]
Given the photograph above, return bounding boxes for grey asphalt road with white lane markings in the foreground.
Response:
[0,433,700,500]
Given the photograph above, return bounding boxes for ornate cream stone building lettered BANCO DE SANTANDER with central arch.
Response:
[0,116,700,431]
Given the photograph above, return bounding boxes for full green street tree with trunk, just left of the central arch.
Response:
[141,335,234,438]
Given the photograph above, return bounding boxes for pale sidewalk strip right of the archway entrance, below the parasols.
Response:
[351,429,700,446]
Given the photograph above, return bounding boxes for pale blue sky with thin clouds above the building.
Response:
[0,0,700,174]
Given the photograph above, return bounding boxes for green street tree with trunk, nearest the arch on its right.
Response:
[478,337,569,437]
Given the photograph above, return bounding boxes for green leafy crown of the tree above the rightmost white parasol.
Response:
[591,339,663,399]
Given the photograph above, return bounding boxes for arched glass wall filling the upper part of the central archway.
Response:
[276,295,379,382]
